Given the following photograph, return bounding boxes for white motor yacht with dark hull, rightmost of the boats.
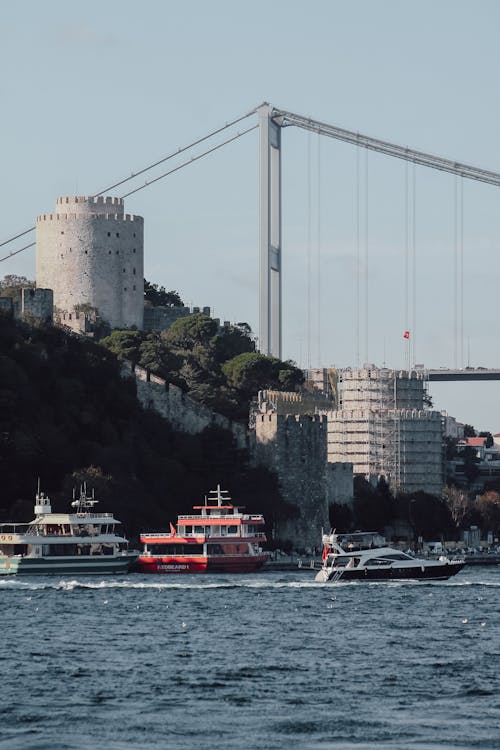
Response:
[315,532,465,583]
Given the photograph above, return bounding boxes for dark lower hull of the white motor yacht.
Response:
[316,562,465,583]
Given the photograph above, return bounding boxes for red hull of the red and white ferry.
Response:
[137,555,268,573]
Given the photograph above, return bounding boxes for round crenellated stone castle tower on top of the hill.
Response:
[36,196,144,328]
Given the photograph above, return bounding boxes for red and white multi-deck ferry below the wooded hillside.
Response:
[138,485,269,573]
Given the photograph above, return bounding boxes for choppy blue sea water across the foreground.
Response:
[0,566,500,750]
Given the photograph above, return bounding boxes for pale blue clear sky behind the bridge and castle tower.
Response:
[0,0,500,432]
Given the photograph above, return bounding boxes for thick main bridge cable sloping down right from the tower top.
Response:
[271,109,500,186]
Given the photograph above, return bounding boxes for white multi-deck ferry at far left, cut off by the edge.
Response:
[0,485,138,575]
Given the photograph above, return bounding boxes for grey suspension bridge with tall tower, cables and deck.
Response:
[0,103,500,381]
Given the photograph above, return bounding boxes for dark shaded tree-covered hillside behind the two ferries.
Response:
[0,315,287,538]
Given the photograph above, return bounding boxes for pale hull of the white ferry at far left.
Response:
[0,554,137,576]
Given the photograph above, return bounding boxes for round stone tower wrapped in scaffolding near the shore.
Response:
[328,366,444,495]
